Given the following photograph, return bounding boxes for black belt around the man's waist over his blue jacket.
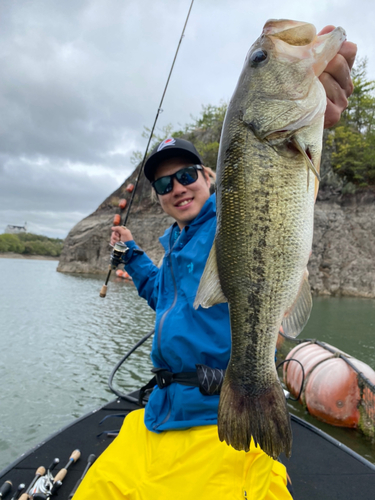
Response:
[138,365,225,406]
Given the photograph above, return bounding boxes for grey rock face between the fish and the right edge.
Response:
[309,191,375,298]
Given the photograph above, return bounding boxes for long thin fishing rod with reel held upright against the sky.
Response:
[99,0,194,298]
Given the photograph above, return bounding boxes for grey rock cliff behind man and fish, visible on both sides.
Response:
[57,169,375,298]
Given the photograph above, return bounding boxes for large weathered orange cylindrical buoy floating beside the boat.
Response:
[283,342,375,427]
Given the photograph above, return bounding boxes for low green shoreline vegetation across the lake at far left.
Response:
[0,233,64,260]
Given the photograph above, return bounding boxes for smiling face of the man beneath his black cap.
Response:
[155,158,210,229]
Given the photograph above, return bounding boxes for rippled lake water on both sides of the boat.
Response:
[0,259,375,470]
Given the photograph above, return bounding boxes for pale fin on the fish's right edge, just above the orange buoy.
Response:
[281,271,312,338]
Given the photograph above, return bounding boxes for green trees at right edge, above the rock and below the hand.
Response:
[327,59,375,188]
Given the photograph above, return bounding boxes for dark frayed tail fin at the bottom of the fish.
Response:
[218,377,292,459]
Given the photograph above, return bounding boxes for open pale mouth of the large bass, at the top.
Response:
[262,19,346,76]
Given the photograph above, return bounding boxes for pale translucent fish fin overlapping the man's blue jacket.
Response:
[194,240,228,309]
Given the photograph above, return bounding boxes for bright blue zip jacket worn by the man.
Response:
[126,195,231,432]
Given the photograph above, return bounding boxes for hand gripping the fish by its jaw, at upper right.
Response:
[319,26,357,128]
